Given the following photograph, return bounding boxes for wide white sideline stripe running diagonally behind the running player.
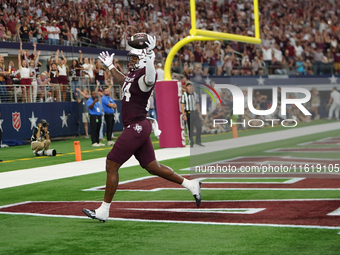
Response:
[0,122,340,189]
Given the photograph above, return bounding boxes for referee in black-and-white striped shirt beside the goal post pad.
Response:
[181,82,204,147]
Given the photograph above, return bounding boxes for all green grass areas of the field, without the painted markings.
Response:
[0,120,340,254]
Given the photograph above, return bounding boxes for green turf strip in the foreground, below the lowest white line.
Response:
[0,216,339,255]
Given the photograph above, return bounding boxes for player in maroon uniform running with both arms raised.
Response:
[83,35,201,222]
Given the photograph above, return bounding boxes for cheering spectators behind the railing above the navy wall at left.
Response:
[0,42,123,103]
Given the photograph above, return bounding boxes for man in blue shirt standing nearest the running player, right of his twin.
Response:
[102,86,117,146]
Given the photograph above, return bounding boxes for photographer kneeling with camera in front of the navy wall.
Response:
[31,119,57,156]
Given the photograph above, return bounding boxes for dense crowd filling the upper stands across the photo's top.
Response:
[0,0,340,76]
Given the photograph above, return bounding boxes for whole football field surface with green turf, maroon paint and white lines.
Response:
[0,122,340,254]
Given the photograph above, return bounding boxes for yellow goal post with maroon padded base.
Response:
[156,0,261,148]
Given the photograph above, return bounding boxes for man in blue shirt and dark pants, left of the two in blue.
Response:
[86,90,105,147]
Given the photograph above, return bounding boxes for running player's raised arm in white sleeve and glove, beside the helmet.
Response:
[145,35,156,86]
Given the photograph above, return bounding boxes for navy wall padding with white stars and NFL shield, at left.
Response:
[0,100,123,140]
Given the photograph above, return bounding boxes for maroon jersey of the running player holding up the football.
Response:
[122,67,157,126]
